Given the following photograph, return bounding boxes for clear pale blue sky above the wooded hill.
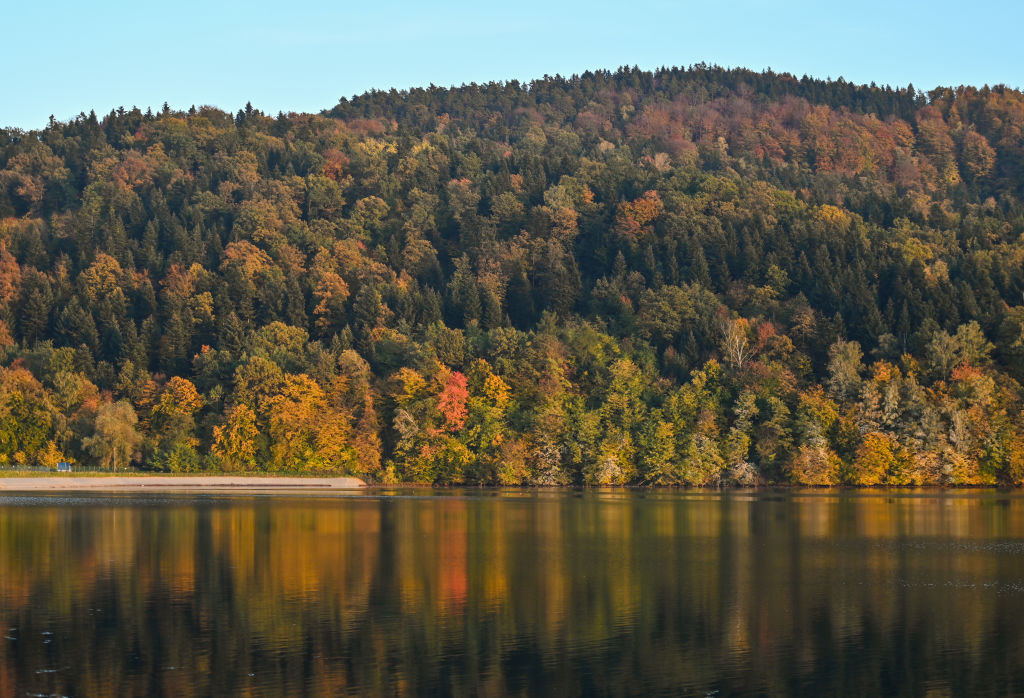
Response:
[0,0,1024,129]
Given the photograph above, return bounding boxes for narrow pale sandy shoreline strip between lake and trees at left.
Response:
[0,475,367,492]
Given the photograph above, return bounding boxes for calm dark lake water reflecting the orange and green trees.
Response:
[0,491,1024,696]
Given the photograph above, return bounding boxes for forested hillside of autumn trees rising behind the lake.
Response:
[0,67,1024,485]
